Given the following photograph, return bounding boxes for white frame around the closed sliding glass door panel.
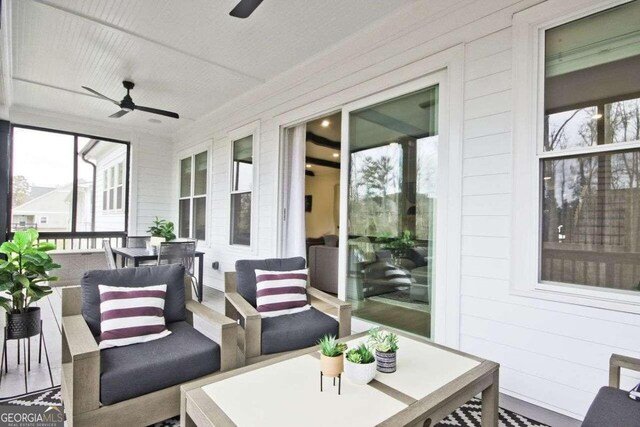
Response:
[338,68,462,347]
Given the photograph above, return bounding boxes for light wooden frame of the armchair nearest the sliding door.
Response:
[224,272,351,364]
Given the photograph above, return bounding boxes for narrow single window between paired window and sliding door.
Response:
[230,135,253,246]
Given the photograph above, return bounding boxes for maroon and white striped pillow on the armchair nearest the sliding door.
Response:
[256,268,311,317]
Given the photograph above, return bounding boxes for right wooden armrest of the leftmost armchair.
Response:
[186,300,238,371]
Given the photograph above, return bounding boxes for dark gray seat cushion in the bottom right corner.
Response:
[582,387,640,427]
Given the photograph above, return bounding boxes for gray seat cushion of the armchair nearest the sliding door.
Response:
[262,307,339,354]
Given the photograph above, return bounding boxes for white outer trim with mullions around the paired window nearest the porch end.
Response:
[176,140,213,247]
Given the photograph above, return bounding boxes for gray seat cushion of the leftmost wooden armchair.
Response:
[100,322,220,405]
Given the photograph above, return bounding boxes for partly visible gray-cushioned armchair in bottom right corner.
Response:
[582,354,640,427]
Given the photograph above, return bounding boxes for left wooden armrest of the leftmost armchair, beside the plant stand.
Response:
[62,315,100,415]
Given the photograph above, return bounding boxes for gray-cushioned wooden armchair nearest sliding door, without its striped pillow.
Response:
[225,257,351,364]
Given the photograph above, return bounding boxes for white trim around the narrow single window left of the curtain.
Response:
[226,120,260,255]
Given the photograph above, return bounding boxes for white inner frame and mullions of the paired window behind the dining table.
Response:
[176,149,211,245]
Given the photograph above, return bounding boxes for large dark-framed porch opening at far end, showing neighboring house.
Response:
[11,126,129,233]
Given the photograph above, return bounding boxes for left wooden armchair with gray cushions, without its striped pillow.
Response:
[62,264,237,427]
